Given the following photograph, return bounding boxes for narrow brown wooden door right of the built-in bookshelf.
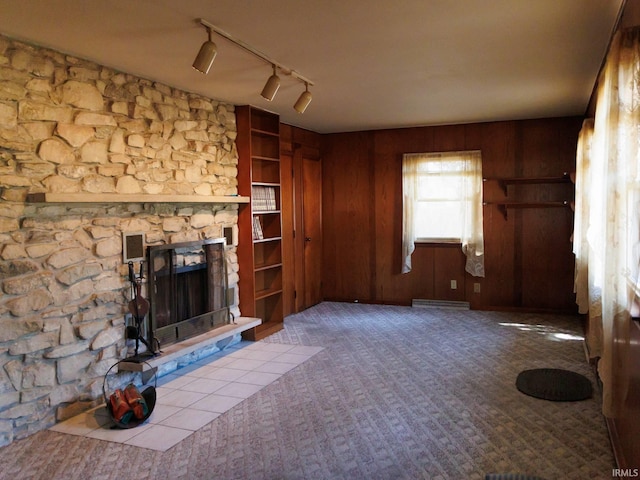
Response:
[300,156,322,309]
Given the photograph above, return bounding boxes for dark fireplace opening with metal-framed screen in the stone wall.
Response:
[148,238,230,346]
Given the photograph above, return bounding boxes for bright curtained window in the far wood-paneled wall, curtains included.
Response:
[402,151,484,277]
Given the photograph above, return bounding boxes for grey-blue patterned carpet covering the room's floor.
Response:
[0,303,614,480]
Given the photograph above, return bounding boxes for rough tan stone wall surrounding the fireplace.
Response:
[0,36,244,445]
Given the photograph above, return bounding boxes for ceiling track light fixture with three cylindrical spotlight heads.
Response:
[193,18,313,113]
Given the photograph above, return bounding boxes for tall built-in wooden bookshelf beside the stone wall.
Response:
[236,106,284,340]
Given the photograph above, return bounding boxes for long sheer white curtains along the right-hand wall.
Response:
[574,29,640,417]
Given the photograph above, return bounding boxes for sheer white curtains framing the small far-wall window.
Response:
[402,151,484,277]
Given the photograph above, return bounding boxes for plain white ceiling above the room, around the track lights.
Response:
[0,0,624,133]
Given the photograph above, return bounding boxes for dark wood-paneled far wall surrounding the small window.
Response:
[321,117,582,312]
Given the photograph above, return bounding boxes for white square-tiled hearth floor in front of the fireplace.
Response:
[50,342,322,451]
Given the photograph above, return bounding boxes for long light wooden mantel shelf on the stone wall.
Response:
[26,193,249,203]
